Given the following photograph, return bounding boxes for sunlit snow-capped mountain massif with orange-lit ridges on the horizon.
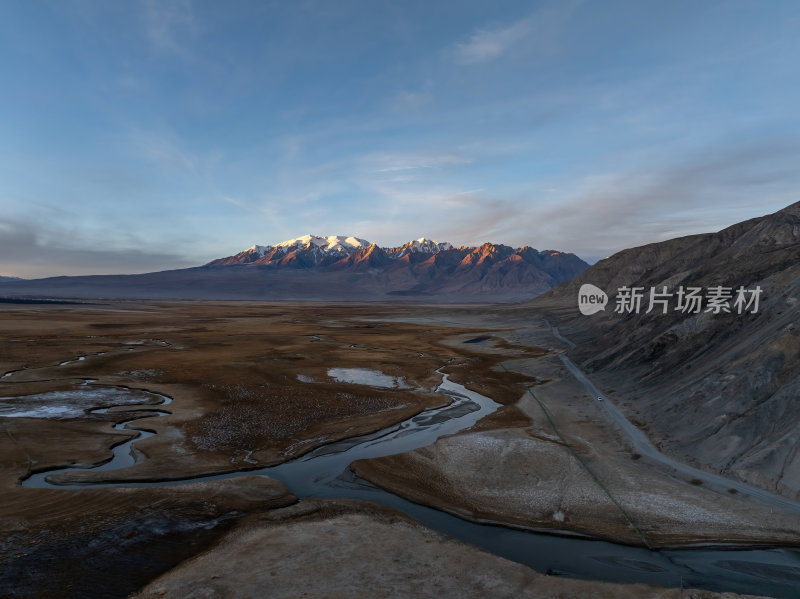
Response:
[206,235,588,301]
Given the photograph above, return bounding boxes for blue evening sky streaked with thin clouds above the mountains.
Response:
[0,0,800,277]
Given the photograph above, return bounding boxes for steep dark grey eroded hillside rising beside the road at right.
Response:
[531,203,800,499]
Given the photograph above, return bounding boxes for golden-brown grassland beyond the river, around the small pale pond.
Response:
[0,302,526,514]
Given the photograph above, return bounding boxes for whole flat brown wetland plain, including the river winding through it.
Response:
[0,302,800,597]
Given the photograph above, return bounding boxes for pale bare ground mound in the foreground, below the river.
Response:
[135,502,768,599]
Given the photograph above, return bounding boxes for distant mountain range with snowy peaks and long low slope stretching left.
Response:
[3,235,588,302]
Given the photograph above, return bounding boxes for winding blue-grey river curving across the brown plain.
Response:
[15,375,800,599]
